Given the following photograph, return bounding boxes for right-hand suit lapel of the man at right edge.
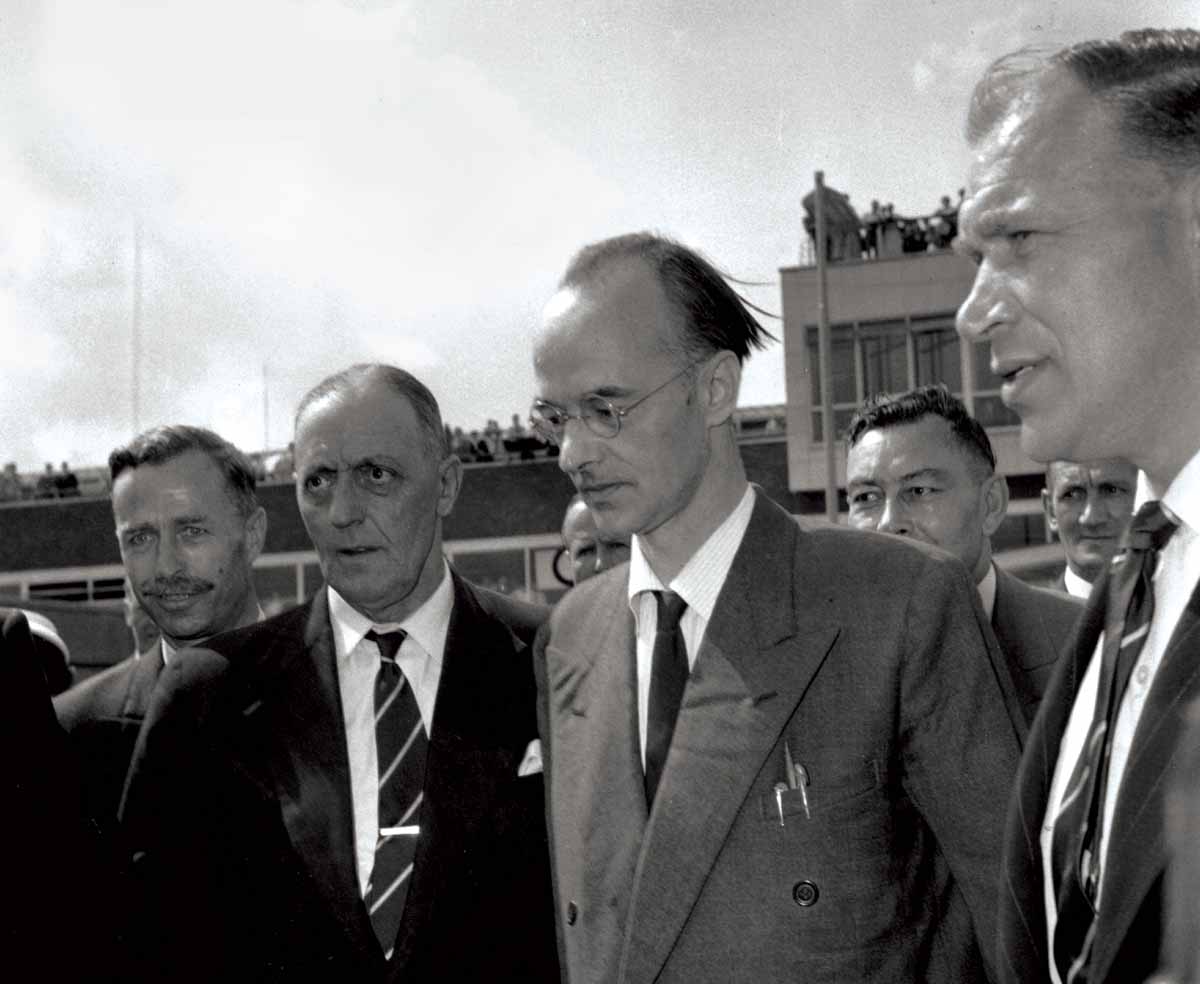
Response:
[1093,587,1200,979]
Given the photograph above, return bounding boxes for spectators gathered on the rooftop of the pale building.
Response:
[803,187,965,262]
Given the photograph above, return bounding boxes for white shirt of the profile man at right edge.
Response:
[1040,451,1200,984]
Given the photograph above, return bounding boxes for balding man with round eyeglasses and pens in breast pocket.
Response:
[533,233,1024,984]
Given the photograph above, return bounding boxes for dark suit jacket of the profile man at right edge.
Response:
[998,564,1200,984]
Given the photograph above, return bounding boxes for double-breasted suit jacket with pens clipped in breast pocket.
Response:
[534,492,1024,984]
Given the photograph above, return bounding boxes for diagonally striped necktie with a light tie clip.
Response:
[365,630,428,958]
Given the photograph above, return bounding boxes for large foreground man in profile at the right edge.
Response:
[959,30,1200,984]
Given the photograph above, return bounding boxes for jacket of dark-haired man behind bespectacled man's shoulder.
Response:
[991,568,1084,722]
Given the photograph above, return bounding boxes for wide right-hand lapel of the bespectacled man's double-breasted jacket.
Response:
[620,493,838,984]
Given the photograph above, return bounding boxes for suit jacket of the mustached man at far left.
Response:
[54,643,162,826]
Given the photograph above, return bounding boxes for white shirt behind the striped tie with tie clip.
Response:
[328,562,454,895]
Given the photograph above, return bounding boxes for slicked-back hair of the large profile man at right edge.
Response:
[967,29,1200,173]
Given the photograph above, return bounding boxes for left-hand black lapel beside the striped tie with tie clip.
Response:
[241,590,378,947]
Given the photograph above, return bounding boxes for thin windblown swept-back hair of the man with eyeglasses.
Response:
[559,233,775,364]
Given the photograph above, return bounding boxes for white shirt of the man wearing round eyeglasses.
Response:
[629,484,754,768]
